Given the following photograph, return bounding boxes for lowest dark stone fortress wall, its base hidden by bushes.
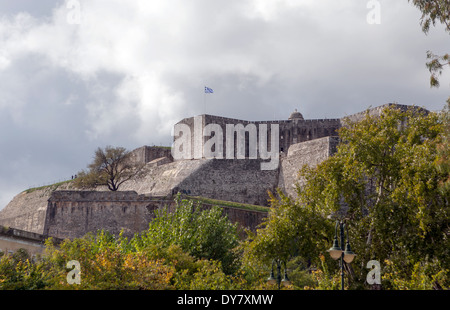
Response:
[44,191,267,239]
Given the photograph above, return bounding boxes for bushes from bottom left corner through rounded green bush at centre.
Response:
[0,196,253,290]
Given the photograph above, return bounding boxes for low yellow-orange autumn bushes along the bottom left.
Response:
[40,231,245,290]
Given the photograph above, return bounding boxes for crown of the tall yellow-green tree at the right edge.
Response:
[334,108,450,276]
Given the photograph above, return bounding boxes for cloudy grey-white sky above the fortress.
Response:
[0,0,450,208]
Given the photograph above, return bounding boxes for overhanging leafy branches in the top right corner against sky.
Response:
[408,0,450,87]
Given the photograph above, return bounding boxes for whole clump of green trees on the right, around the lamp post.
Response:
[244,107,450,286]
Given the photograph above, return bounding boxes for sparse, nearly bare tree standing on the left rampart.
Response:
[74,146,143,191]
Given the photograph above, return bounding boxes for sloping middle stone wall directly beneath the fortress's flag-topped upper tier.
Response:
[120,159,278,205]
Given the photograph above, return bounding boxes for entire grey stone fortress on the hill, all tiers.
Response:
[0,104,416,247]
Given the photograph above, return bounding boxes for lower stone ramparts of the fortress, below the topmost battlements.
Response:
[0,133,337,238]
